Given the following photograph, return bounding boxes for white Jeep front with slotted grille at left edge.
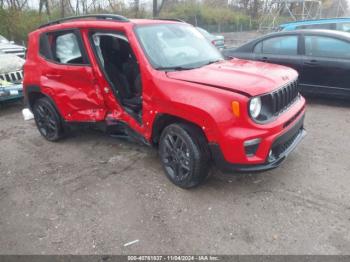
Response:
[0,51,24,102]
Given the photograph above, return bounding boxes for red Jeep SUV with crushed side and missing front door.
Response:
[24,15,305,188]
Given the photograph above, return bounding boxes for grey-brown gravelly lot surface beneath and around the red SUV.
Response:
[0,99,350,254]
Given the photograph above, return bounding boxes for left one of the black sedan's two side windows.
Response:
[254,35,298,55]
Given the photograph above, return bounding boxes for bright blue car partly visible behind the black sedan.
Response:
[278,17,350,32]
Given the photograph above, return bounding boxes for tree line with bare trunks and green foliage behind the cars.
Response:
[0,0,347,42]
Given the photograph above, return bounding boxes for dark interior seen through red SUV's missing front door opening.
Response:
[92,33,142,116]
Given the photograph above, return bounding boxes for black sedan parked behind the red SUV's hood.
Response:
[224,30,350,98]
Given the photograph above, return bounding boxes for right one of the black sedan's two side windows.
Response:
[305,36,350,58]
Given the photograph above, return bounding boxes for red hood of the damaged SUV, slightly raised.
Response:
[167,59,298,96]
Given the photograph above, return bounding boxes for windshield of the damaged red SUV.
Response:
[136,24,223,70]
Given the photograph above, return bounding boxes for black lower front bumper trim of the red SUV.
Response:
[209,115,306,172]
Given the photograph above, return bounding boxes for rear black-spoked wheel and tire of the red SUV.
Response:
[33,97,64,142]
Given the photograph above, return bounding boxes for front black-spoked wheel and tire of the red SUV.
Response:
[159,123,210,189]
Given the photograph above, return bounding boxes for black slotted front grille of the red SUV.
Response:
[267,79,299,116]
